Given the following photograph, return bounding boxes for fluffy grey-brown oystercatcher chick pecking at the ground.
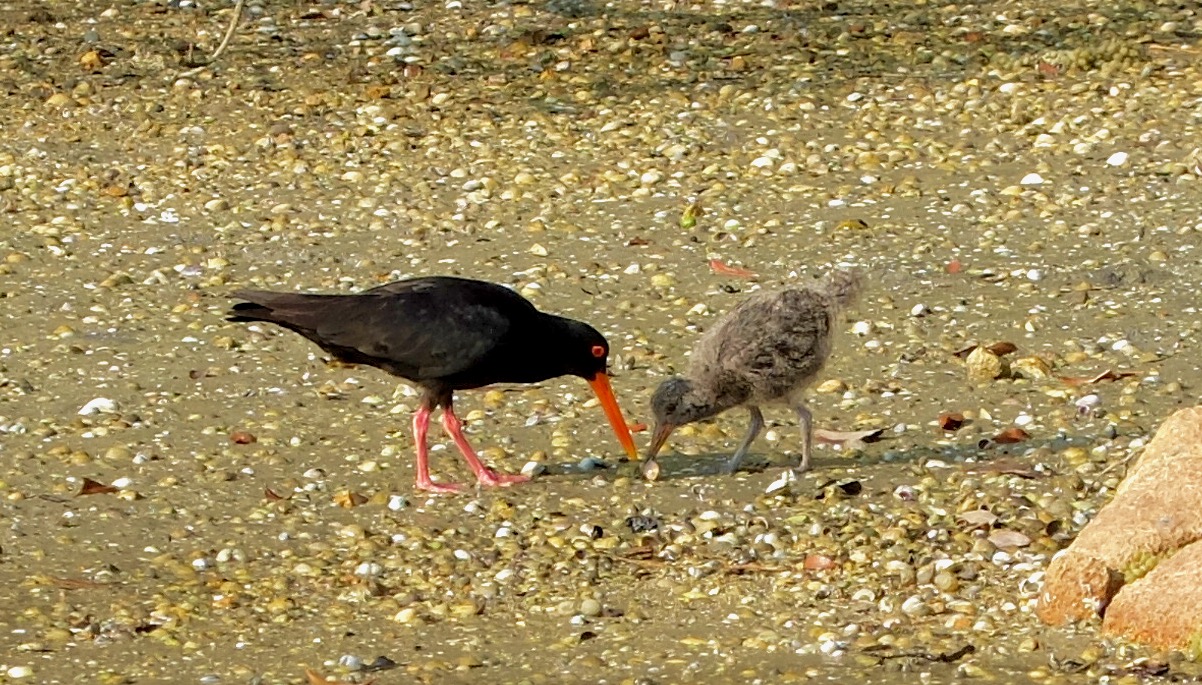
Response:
[643,270,859,478]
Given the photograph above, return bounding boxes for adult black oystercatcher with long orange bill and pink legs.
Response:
[230,276,638,493]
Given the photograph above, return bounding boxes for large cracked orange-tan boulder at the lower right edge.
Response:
[1036,406,1202,648]
